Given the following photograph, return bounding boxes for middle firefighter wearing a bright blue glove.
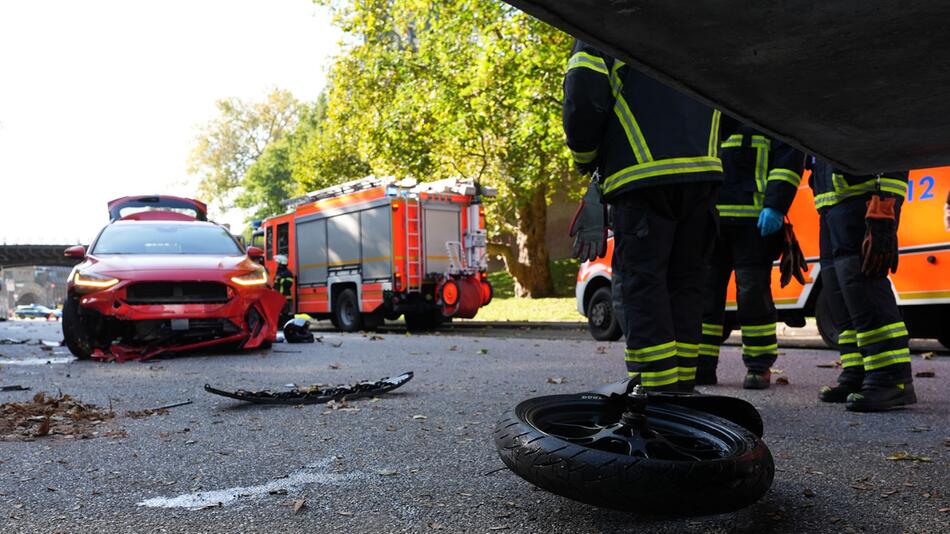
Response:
[696,129,805,389]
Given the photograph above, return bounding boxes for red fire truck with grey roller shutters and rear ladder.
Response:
[256,177,495,332]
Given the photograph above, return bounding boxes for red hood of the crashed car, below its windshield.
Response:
[89,254,258,273]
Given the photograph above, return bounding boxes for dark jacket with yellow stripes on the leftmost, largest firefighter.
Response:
[563,41,732,200]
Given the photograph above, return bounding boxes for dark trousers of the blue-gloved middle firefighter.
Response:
[699,223,782,375]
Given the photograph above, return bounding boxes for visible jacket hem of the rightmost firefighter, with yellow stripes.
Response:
[809,157,909,210]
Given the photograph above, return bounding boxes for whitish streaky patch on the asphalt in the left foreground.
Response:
[138,457,366,510]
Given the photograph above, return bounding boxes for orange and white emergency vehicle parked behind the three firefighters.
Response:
[576,167,950,348]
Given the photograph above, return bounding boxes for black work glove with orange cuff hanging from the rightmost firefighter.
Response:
[861,195,899,278]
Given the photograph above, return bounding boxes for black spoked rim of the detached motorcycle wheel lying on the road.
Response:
[524,397,748,462]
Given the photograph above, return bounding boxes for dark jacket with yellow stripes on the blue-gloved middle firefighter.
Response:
[716,125,805,224]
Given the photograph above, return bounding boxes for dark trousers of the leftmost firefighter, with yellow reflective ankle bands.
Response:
[612,182,719,390]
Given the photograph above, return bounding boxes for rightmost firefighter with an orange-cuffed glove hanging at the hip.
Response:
[810,160,917,412]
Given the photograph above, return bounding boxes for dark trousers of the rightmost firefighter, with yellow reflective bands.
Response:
[819,195,913,387]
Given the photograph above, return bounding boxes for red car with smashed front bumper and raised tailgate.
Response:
[63,196,285,361]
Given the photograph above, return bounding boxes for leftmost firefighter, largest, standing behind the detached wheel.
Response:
[563,41,728,391]
